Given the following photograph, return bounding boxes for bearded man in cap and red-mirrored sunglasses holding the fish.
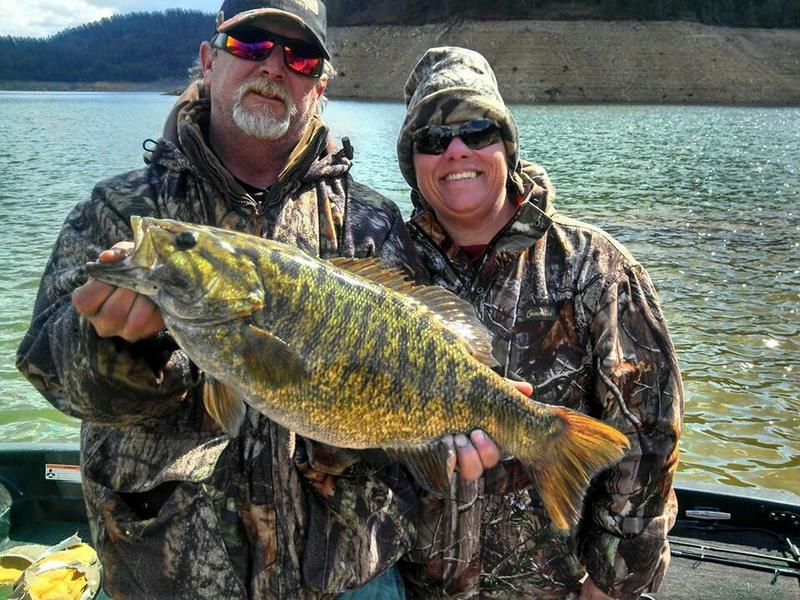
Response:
[17,0,424,600]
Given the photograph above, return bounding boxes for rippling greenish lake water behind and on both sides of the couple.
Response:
[0,92,800,495]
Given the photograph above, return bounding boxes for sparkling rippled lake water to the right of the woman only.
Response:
[504,106,800,493]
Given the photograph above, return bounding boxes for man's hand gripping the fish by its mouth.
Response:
[72,242,164,342]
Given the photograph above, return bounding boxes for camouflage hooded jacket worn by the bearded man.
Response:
[17,83,420,600]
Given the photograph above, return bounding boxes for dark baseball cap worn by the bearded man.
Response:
[217,0,331,60]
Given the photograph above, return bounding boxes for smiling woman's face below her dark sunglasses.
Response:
[414,123,508,225]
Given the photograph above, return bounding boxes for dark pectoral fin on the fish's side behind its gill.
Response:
[242,324,309,389]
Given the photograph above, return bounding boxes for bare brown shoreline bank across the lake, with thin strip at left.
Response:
[0,21,800,106]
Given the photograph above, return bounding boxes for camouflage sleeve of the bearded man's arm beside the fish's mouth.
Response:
[17,184,191,426]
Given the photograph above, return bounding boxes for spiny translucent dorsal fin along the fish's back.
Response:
[329,258,498,367]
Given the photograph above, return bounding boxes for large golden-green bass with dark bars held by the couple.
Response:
[87,217,628,528]
